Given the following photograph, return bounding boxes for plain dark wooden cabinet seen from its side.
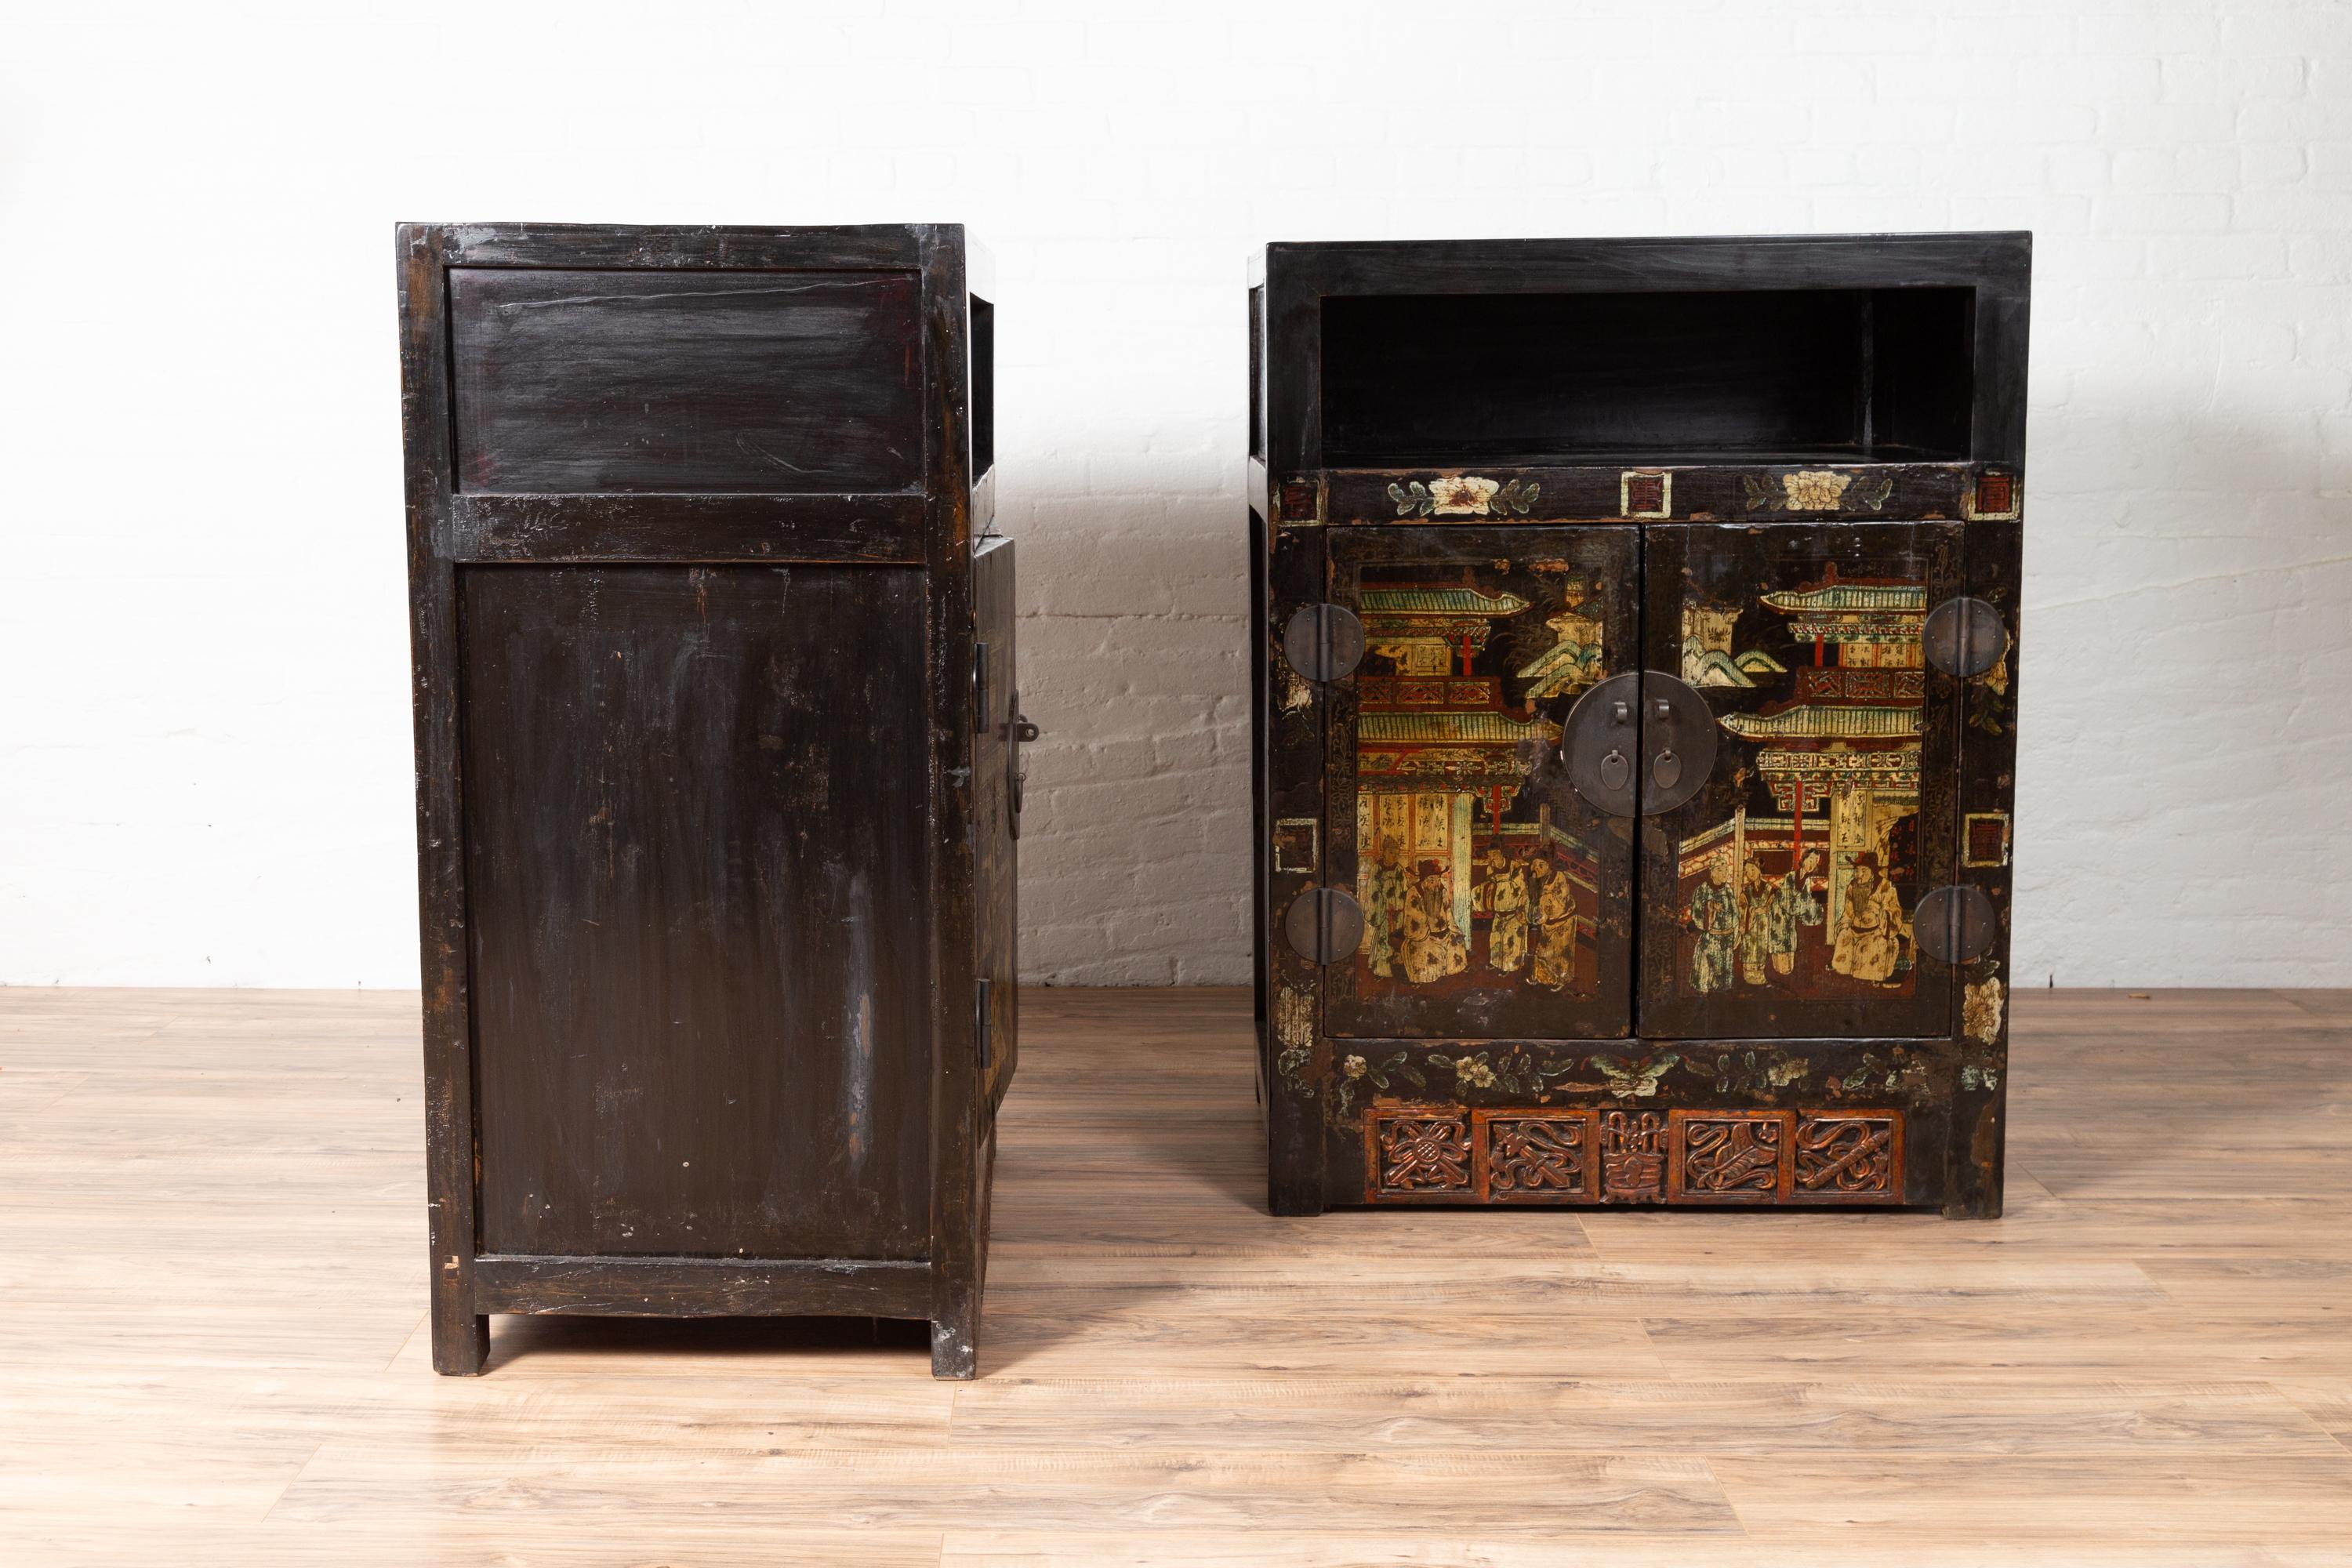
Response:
[397,223,1025,1377]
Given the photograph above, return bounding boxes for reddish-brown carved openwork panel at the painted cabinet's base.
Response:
[1364,1100,1903,1206]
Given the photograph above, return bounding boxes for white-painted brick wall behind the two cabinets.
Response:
[0,0,2352,985]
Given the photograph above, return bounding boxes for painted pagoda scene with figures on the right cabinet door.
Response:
[1677,564,1926,996]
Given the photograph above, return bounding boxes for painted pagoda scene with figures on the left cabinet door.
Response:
[1355,562,1606,996]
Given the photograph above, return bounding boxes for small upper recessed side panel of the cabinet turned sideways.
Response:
[449,268,924,494]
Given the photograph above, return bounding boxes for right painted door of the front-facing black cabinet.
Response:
[1639,522,1962,1039]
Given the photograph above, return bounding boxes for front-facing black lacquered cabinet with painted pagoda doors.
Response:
[1249,233,2030,1215]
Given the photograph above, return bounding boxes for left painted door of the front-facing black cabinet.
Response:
[1324,524,1639,1039]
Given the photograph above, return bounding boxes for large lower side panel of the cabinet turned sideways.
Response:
[459,567,929,1258]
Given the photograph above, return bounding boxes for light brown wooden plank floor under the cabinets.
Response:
[0,989,2352,1568]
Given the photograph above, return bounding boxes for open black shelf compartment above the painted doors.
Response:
[1319,287,1976,468]
